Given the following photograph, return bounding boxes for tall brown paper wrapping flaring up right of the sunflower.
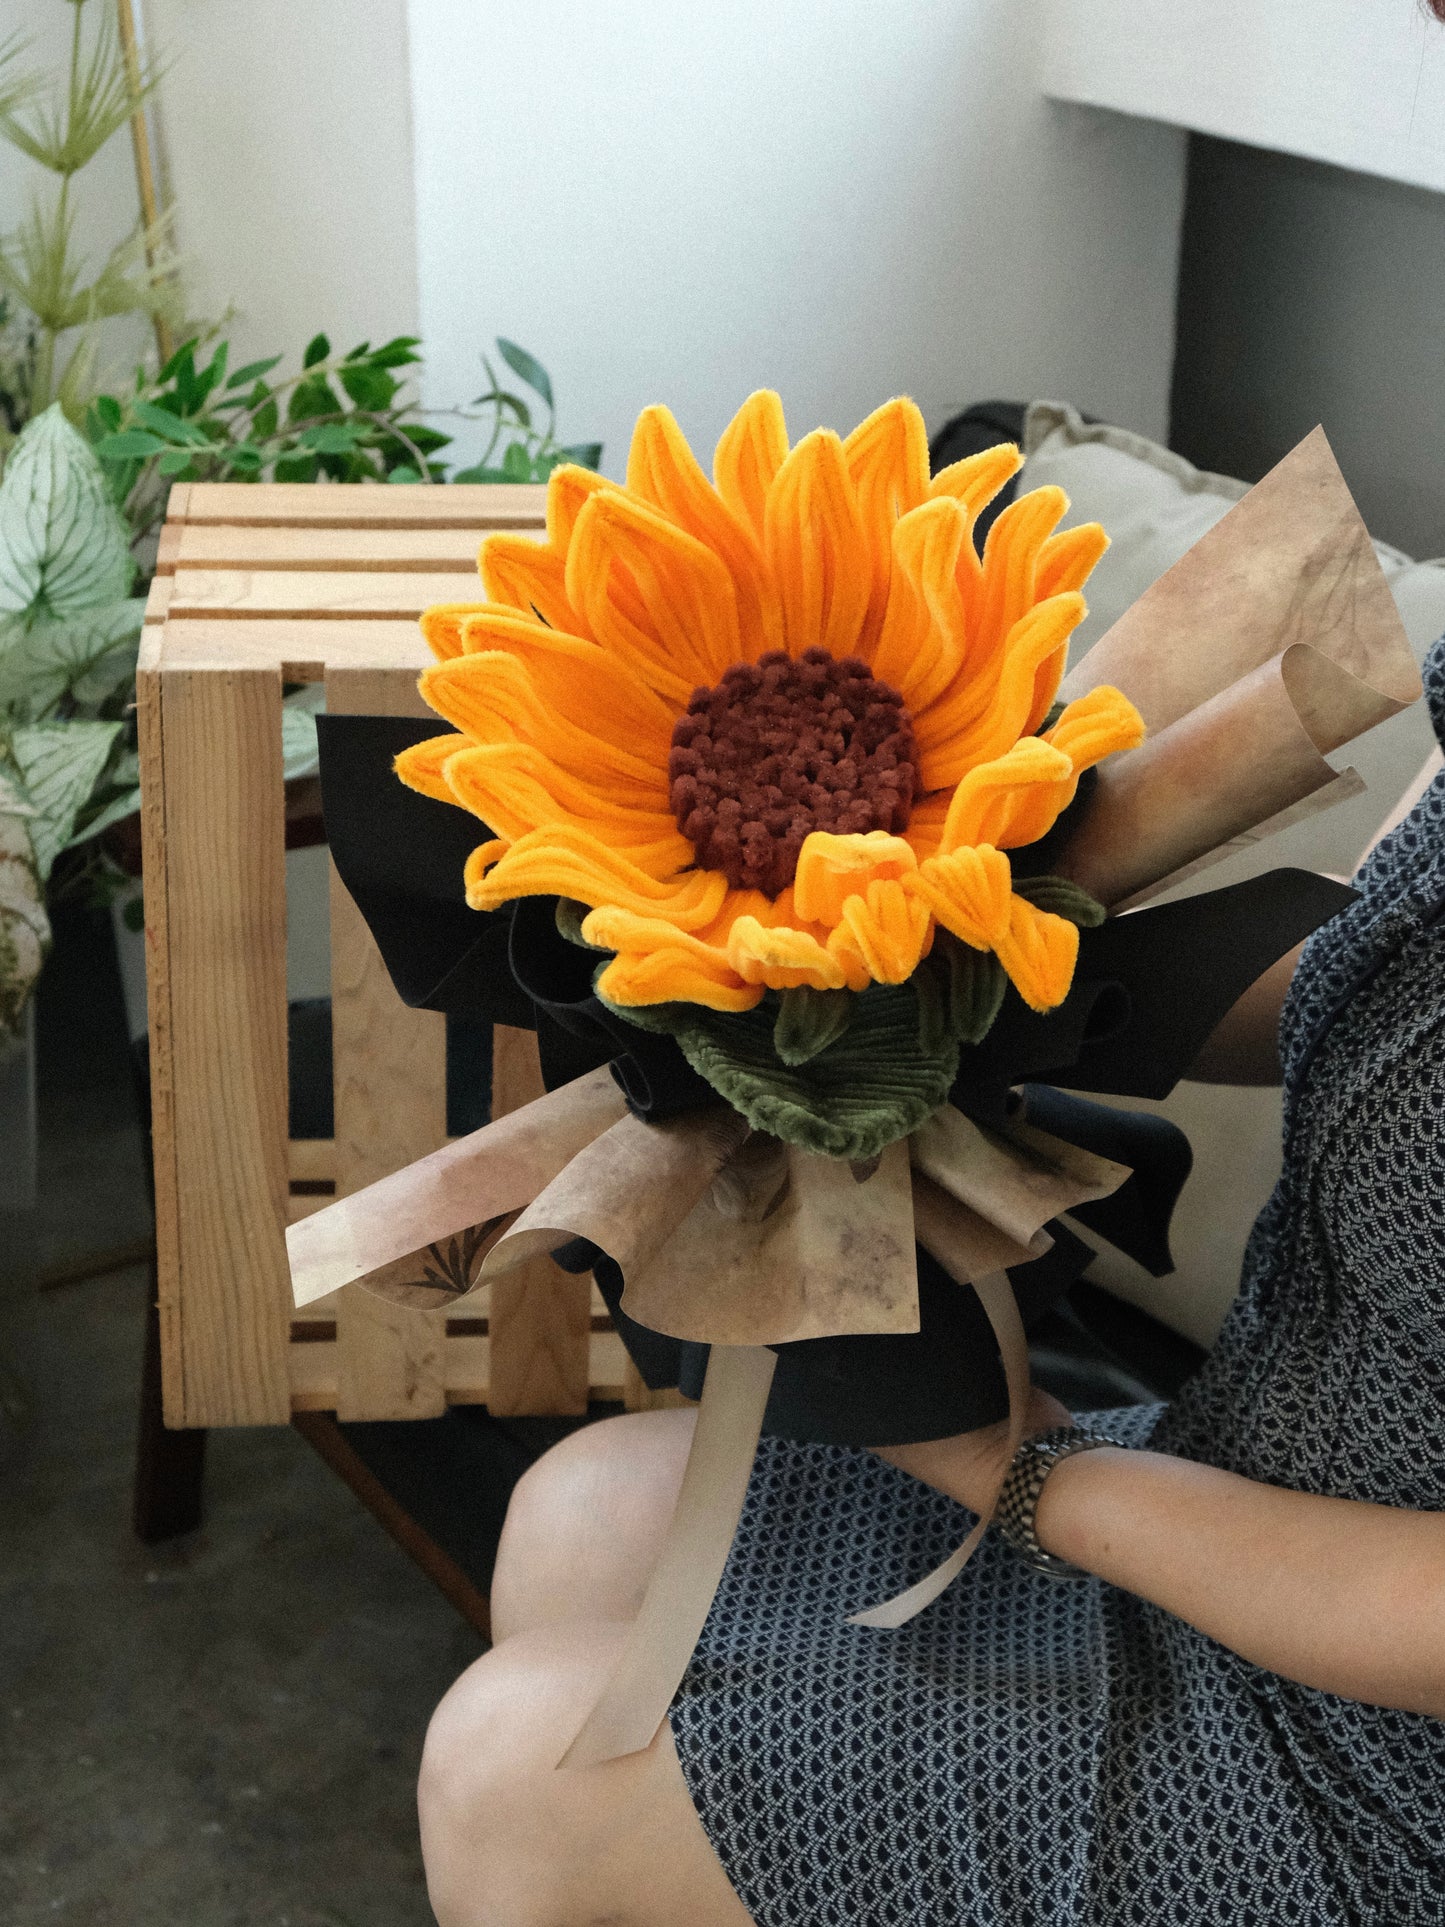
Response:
[1058,428,1420,908]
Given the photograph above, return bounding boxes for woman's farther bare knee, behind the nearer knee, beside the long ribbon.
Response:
[491,1411,694,1640]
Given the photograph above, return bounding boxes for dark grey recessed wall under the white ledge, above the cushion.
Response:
[1169,135,1445,555]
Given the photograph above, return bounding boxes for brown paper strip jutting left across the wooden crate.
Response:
[285,1066,626,1305]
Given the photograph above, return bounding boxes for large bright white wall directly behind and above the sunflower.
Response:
[408,0,1183,474]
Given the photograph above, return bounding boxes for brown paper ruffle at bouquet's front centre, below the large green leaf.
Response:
[622,1143,919,1345]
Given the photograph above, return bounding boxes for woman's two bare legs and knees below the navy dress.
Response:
[420,1412,749,1927]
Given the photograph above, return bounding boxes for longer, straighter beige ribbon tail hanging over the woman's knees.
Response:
[559,1345,778,1767]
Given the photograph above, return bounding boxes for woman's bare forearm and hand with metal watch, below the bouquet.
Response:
[882,1391,1445,1719]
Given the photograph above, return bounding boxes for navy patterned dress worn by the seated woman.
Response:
[672,642,1445,1927]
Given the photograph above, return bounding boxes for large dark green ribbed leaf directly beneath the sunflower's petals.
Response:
[611,985,958,1160]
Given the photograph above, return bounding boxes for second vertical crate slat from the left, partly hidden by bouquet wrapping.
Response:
[326,669,447,1418]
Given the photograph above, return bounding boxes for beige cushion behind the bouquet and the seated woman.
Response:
[1023,401,1445,1345]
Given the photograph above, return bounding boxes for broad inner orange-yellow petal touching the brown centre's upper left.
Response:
[566,489,740,707]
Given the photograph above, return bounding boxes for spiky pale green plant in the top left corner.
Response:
[0,0,181,437]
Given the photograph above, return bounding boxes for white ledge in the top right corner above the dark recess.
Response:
[1044,0,1445,187]
